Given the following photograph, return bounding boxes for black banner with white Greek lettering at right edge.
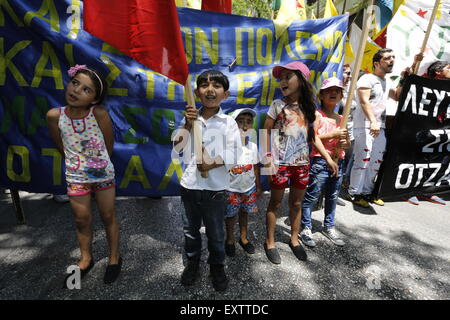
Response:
[376,75,450,199]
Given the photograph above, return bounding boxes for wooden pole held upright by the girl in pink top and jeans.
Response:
[332,0,374,162]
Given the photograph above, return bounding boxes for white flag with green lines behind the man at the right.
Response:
[386,5,450,75]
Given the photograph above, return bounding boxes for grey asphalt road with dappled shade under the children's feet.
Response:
[0,192,450,300]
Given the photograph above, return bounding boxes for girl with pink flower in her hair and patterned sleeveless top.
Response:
[47,65,122,288]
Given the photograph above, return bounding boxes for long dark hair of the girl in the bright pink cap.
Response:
[292,70,316,143]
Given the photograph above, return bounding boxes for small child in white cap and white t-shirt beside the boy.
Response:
[225,108,262,257]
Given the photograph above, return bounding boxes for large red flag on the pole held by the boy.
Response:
[83,0,189,85]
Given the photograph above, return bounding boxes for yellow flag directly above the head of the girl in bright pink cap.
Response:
[273,0,306,39]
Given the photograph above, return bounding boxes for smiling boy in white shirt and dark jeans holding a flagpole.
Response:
[174,70,242,291]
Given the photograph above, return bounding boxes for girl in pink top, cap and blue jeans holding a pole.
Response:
[300,77,350,247]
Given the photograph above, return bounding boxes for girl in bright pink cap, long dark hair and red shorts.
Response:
[263,61,338,264]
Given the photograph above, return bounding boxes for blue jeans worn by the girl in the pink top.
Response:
[301,157,344,229]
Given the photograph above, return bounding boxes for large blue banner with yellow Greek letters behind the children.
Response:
[0,0,348,196]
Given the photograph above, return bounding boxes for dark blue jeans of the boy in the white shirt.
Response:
[181,187,226,265]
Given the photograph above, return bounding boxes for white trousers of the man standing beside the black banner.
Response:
[348,128,386,195]
